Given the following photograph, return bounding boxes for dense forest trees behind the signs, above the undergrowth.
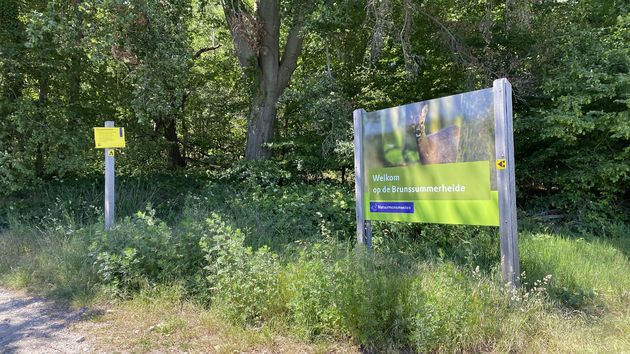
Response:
[0,0,630,223]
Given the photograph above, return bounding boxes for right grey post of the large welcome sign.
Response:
[493,79,521,288]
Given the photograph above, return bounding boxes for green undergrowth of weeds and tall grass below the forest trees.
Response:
[0,163,630,352]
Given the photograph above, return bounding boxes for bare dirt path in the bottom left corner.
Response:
[0,288,93,353]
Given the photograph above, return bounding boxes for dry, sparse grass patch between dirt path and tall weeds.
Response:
[84,286,358,353]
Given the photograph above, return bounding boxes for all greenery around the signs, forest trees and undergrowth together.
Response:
[0,0,630,352]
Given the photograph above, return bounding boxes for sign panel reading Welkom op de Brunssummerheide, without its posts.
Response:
[362,89,499,226]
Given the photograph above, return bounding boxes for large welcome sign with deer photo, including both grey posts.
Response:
[353,79,520,287]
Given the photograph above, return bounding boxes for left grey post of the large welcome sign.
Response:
[352,108,372,248]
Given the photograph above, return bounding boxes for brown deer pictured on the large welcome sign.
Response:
[415,104,460,165]
